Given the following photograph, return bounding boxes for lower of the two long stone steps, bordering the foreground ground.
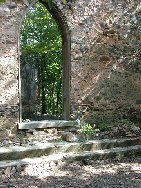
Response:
[0,145,141,169]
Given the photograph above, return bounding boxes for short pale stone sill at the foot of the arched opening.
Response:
[18,120,78,130]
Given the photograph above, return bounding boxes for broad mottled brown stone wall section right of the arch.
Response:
[67,0,141,123]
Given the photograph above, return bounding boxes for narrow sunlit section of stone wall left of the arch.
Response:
[0,1,27,126]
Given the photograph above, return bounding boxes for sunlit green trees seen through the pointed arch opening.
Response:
[20,1,62,117]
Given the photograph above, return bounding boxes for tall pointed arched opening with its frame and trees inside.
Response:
[19,1,70,122]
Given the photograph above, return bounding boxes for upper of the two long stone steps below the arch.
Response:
[0,137,141,161]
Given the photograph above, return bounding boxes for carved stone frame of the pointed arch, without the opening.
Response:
[18,0,71,123]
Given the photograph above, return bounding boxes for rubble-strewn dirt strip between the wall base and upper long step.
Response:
[0,119,141,147]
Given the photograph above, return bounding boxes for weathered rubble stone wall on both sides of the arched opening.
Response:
[0,0,141,128]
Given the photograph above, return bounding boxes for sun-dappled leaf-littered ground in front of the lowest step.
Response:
[0,157,141,188]
